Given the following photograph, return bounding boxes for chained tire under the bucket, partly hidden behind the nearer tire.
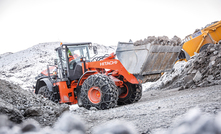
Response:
[117,82,142,105]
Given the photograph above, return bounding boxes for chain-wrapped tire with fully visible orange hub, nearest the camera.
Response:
[80,74,118,110]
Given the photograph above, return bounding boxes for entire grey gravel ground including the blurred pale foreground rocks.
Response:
[0,85,221,134]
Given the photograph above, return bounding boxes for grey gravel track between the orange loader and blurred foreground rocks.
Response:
[72,85,221,134]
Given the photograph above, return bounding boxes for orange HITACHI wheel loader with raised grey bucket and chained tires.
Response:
[35,42,181,110]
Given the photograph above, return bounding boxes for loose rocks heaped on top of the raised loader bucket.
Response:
[134,35,181,46]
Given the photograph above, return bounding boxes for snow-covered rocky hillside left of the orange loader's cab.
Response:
[0,42,60,89]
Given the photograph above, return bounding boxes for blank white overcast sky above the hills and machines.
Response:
[0,0,221,54]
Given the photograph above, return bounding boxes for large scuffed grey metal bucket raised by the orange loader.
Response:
[116,42,182,83]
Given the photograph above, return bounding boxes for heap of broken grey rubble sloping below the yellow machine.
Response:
[161,43,221,89]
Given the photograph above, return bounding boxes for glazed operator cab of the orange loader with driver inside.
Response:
[55,42,91,81]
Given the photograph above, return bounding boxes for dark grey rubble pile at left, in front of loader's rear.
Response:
[0,80,69,126]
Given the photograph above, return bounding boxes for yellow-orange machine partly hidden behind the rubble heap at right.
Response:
[178,21,221,61]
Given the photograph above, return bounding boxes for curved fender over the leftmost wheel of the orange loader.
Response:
[35,78,53,94]
